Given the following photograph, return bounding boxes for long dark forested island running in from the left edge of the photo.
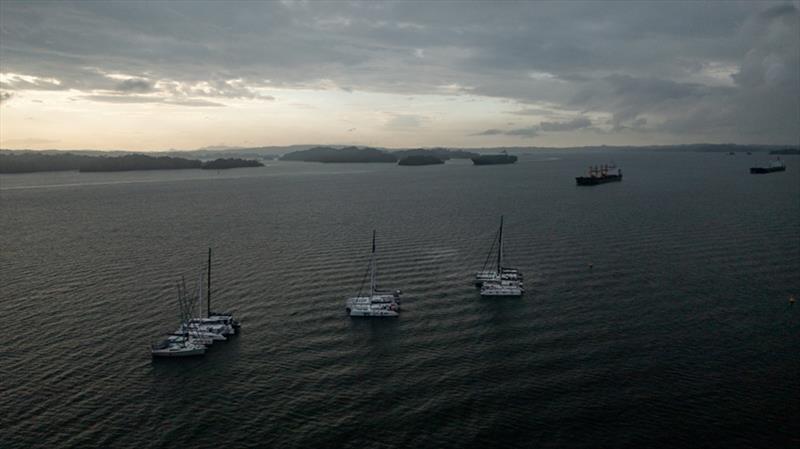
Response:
[0,151,263,173]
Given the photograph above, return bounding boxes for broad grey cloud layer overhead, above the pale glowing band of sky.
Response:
[0,1,800,142]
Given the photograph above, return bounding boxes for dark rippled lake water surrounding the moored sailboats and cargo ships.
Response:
[0,151,800,448]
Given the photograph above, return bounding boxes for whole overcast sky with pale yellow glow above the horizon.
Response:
[0,0,800,151]
